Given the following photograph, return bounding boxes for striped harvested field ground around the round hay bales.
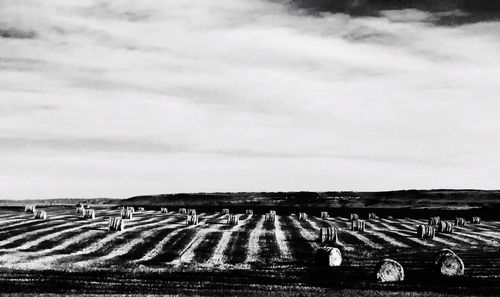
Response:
[0,206,500,296]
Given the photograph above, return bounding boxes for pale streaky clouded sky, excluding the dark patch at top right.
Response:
[0,0,500,199]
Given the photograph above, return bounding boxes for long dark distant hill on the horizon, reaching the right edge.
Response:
[119,190,500,209]
